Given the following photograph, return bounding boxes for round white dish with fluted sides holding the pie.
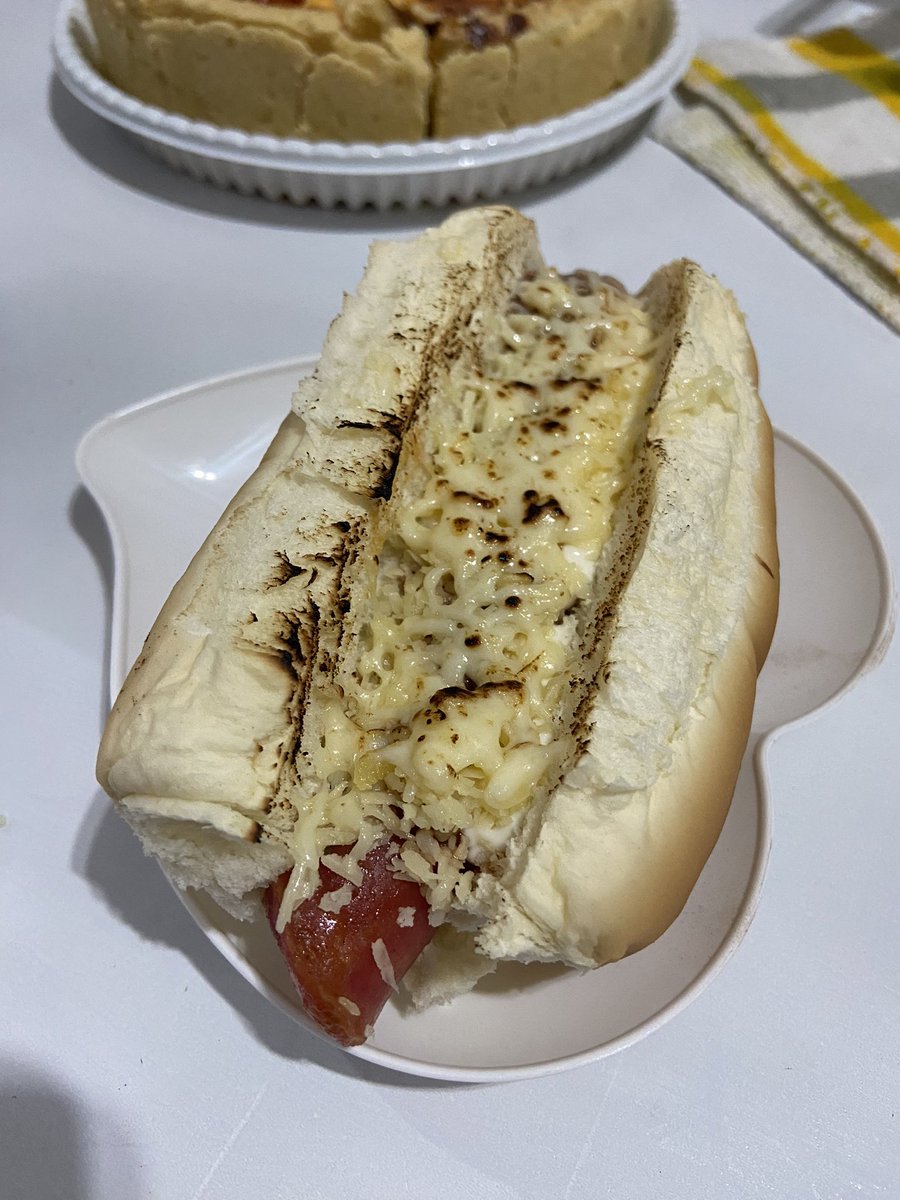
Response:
[53,0,692,209]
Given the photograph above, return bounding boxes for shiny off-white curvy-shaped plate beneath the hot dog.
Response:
[78,359,892,1081]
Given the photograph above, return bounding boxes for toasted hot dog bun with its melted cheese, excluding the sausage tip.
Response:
[98,208,778,1001]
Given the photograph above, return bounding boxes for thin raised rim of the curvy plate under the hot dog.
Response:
[74,354,895,1084]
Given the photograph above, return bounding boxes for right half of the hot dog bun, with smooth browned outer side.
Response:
[478,263,779,966]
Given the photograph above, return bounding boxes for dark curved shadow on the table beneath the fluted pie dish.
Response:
[48,76,653,236]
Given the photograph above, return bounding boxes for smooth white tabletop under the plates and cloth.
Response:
[0,0,900,1200]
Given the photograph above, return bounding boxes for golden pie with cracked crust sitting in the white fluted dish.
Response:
[86,0,667,143]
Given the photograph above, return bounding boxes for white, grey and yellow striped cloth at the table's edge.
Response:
[655,12,900,330]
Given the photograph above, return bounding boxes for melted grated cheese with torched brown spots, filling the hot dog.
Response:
[282,270,659,919]
